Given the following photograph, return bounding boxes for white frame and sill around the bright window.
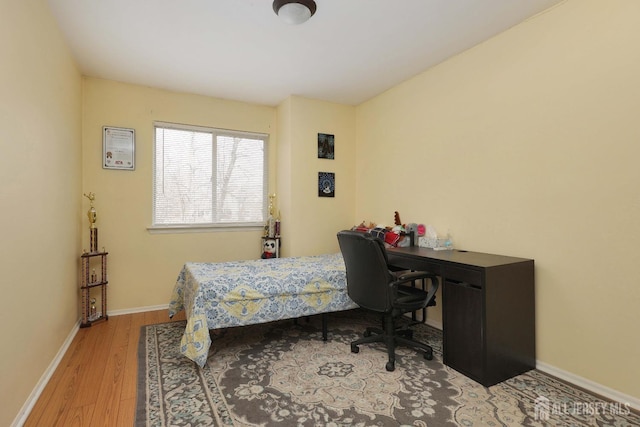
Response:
[147,122,269,233]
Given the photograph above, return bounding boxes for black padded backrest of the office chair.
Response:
[338,230,394,312]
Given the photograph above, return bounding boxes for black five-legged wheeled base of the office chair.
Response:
[351,316,433,372]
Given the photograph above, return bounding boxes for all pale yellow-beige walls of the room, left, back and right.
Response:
[6,0,640,425]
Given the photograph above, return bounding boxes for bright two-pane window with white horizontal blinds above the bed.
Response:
[153,123,267,228]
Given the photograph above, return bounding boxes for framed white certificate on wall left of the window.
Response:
[102,126,136,170]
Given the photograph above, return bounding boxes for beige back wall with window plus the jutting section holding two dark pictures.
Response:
[82,82,355,312]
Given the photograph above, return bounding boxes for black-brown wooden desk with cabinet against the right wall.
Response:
[387,246,536,387]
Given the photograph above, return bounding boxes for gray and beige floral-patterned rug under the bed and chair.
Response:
[136,310,640,427]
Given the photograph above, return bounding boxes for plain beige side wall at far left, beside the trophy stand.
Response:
[0,0,82,426]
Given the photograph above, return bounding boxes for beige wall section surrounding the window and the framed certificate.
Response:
[82,78,277,311]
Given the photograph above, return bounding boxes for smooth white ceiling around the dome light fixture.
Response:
[48,0,562,106]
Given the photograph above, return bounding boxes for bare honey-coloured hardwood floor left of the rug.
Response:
[24,310,184,427]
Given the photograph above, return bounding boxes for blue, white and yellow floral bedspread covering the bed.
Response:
[169,253,357,366]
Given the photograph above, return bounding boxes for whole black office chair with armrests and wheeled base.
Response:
[338,231,439,371]
